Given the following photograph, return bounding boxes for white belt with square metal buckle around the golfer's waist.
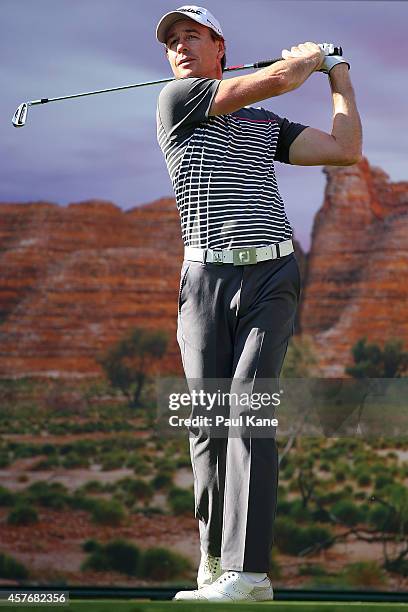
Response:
[184,240,294,266]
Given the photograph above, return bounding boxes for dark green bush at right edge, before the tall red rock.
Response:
[345,337,408,378]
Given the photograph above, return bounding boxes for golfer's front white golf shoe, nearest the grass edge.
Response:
[173,571,273,602]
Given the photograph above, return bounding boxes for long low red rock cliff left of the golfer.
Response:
[0,199,182,377]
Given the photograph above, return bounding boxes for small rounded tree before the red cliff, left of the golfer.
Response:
[97,327,168,407]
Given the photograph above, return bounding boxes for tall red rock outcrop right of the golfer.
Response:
[300,159,408,376]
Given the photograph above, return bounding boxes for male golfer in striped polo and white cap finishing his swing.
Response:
[156,6,362,602]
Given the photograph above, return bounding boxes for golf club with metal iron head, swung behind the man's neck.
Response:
[12,43,343,127]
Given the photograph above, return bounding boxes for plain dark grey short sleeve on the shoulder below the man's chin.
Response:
[157,77,221,138]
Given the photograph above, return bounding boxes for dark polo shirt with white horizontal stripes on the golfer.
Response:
[157,77,307,249]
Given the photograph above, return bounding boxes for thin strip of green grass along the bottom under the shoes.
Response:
[1,599,408,612]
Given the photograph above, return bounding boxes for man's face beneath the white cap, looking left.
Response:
[166,19,224,79]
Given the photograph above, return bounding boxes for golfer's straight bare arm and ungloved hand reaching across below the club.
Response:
[209,42,324,115]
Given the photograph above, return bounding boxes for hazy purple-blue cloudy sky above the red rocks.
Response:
[0,0,408,249]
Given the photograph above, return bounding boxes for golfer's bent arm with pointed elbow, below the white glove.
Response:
[289,64,362,166]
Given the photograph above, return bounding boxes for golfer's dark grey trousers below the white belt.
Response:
[177,253,301,572]
